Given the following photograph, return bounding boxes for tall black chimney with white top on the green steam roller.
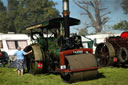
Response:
[63,0,70,37]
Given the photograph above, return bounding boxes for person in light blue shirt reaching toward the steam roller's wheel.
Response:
[14,47,32,76]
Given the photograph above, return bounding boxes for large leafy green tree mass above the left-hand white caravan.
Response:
[0,0,59,33]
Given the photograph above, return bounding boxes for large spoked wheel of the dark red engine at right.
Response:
[95,43,115,67]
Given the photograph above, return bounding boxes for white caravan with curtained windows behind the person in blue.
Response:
[0,33,30,57]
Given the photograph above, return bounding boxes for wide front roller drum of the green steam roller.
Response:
[61,53,97,83]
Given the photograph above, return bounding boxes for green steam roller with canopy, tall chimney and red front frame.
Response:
[25,0,98,83]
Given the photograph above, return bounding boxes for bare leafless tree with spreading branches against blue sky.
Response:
[73,0,110,33]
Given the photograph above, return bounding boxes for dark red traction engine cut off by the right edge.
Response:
[95,32,128,66]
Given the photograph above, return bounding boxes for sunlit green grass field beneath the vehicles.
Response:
[0,67,128,85]
